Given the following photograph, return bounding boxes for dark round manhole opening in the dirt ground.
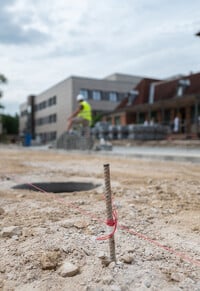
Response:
[12,182,100,193]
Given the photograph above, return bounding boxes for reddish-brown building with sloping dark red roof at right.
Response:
[104,73,200,137]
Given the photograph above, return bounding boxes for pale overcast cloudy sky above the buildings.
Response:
[0,0,200,115]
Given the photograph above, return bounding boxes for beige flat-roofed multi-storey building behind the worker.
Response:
[20,74,143,142]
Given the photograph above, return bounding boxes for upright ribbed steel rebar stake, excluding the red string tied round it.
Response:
[104,164,116,261]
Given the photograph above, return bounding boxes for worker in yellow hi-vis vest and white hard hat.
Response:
[67,94,92,135]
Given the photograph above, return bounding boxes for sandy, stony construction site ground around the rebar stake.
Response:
[0,146,200,291]
